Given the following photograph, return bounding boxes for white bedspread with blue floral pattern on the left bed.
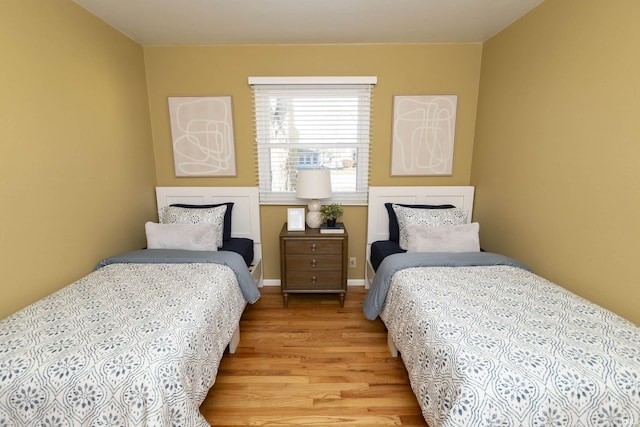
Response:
[0,264,246,426]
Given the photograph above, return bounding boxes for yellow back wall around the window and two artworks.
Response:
[144,44,482,279]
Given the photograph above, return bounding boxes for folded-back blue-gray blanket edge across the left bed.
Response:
[96,249,260,304]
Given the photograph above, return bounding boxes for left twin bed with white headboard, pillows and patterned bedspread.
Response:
[0,187,262,426]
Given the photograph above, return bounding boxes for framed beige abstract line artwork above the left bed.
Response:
[169,96,236,177]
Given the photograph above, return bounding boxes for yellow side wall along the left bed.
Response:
[0,0,156,318]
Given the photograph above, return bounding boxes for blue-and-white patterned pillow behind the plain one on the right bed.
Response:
[393,204,467,250]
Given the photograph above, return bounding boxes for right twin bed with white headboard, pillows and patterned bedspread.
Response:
[363,187,640,427]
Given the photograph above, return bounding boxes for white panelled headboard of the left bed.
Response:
[156,187,262,260]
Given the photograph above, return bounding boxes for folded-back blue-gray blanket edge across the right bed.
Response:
[362,252,529,320]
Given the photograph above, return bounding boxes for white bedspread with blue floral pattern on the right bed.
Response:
[380,266,640,427]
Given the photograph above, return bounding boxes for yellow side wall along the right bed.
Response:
[471,0,640,323]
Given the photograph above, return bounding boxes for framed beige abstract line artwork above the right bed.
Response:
[391,95,458,176]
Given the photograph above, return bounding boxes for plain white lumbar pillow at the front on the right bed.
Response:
[407,222,480,252]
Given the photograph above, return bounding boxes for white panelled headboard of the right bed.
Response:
[365,186,475,287]
